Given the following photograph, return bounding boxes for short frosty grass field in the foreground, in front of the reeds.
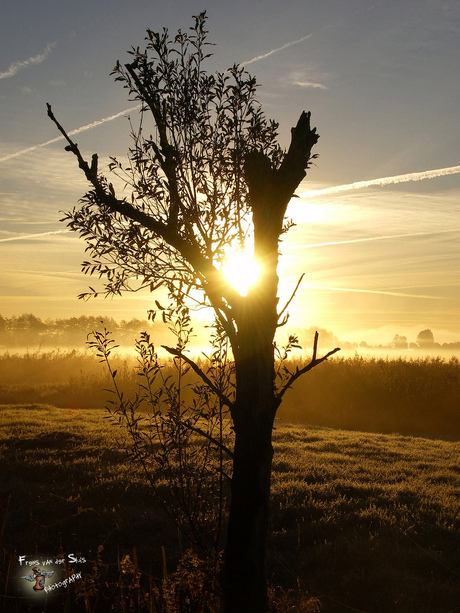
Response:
[0,404,460,613]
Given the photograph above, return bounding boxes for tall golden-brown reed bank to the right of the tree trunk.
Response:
[280,357,460,440]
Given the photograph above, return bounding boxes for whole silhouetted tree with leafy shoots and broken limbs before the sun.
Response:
[48,13,336,613]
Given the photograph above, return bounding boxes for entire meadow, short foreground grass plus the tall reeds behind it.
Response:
[0,351,460,613]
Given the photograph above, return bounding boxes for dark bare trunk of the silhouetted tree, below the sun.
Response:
[223,296,276,613]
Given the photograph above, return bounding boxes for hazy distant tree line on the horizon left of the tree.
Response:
[0,313,164,348]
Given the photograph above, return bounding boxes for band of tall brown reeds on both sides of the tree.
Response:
[0,351,460,440]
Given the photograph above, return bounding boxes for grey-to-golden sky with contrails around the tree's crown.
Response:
[0,0,460,343]
